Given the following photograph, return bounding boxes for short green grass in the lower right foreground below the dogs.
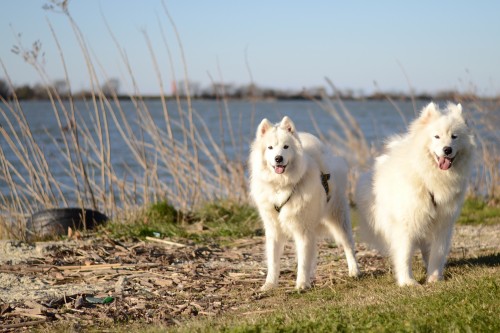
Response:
[204,268,500,332]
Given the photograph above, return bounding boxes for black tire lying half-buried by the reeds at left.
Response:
[26,208,109,238]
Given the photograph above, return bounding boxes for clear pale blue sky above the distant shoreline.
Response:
[0,0,500,96]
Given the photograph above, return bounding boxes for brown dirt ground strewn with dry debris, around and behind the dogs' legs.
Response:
[0,225,500,331]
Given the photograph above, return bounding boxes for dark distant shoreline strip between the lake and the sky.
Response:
[0,78,500,102]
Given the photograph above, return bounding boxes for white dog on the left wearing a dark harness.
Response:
[249,117,359,290]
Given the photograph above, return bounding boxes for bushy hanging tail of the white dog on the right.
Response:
[355,172,387,254]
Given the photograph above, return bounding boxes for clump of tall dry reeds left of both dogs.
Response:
[0,2,247,238]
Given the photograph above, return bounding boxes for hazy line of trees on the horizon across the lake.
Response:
[0,79,492,101]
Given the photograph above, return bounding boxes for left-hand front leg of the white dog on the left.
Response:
[260,227,285,291]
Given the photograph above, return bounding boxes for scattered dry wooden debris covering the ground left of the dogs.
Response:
[0,233,398,331]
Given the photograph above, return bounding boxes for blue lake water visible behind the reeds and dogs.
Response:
[0,100,496,208]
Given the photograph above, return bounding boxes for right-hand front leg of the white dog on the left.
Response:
[295,233,316,290]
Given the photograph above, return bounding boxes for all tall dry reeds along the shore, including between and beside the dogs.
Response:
[0,2,500,238]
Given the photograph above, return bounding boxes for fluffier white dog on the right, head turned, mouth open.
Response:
[356,103,475,286]
